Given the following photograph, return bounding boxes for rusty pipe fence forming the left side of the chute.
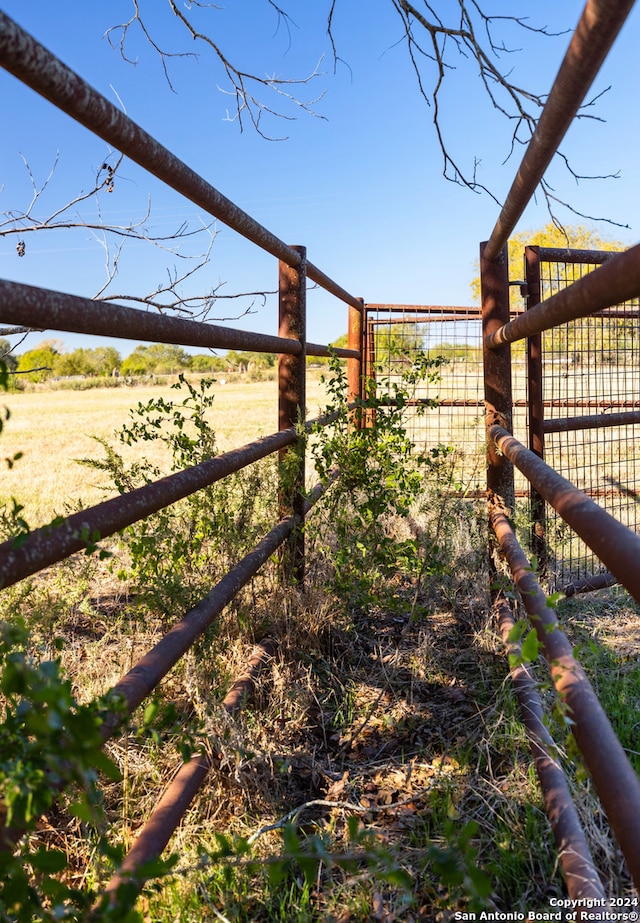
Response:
[0,11,363,893]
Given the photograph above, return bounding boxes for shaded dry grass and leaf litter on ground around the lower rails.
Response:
[17,488,640,923]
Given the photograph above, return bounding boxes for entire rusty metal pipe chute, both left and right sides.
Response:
[0,0,640,899]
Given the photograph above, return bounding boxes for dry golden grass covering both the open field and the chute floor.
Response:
[2,366,640,923]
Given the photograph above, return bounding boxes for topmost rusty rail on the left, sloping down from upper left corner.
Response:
[0,11,362,310]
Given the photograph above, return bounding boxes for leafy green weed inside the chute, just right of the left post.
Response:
[311,354,448,608]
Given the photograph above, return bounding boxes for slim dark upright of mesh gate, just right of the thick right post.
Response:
[524,247,548,576]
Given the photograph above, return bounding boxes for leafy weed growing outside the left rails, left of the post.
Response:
[81,375,275,616]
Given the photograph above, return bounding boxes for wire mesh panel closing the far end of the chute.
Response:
[365,305,486,493]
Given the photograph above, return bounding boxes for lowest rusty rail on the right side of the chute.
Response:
[495,596,605,900]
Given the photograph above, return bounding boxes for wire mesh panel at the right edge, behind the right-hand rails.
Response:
[528,248,640,587]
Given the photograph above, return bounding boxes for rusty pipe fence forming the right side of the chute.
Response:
[480,0,640,897]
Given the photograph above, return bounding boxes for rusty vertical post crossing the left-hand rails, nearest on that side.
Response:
[278,247,307,584]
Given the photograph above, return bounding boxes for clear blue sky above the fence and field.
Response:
[0,0,640,355]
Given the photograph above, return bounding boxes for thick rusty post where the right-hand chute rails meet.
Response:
[480,243,515,515]
